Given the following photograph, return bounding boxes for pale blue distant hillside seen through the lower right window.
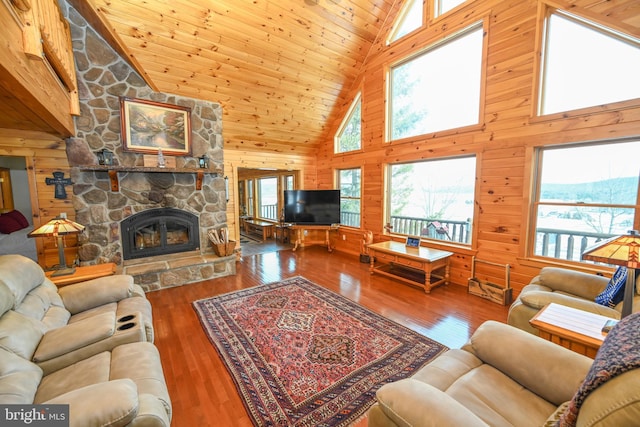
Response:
[540,177,638,205]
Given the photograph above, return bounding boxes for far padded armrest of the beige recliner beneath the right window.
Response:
[537,267,609,301]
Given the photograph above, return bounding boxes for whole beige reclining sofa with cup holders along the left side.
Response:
[0,255,171,427]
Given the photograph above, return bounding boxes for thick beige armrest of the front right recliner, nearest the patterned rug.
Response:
[463,320,593,406]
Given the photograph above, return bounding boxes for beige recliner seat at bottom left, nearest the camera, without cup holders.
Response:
[0,342,171,427]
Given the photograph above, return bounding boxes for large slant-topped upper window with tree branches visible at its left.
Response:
[389,23,483,140]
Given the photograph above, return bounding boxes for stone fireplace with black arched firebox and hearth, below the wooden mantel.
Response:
[70,166,236,291]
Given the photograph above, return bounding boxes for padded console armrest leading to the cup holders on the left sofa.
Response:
[33,312,116,363]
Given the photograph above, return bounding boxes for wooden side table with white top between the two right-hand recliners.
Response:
[529,303,611,359]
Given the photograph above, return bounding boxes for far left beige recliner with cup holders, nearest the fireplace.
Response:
[0,255,153,374]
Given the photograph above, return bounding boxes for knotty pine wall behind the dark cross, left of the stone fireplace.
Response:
[0,129,77,267]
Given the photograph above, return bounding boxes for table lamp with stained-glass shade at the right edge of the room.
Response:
[582,230,640,317]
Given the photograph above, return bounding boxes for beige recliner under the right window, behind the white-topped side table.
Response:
[507,267,640,335]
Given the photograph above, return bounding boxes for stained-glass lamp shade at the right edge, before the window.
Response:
[582,230,640,269]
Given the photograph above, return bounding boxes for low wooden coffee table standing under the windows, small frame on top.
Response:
[367,241,453,293]
